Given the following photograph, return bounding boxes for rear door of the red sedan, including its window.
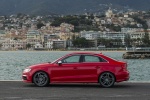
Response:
[77,55,107,82]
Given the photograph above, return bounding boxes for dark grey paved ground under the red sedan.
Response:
[0,81,150,100]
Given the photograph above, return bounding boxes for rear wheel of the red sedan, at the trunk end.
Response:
[99,72,115,88]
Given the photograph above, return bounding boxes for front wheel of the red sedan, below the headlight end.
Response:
[33,71,49,87]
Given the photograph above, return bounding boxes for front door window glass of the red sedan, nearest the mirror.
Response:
[62,55,80,63]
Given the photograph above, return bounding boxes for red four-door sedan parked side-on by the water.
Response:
[22,52,129,87]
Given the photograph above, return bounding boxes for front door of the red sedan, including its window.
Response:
[51,55,81,82]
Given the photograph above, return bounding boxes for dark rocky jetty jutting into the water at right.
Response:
[122,47,150,59]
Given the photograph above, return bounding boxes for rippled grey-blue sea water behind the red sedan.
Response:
[0,51,150,82]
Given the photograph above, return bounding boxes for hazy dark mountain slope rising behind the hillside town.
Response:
[0,0,150,15]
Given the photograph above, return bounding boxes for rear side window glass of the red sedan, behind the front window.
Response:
[83,55,107,62]
